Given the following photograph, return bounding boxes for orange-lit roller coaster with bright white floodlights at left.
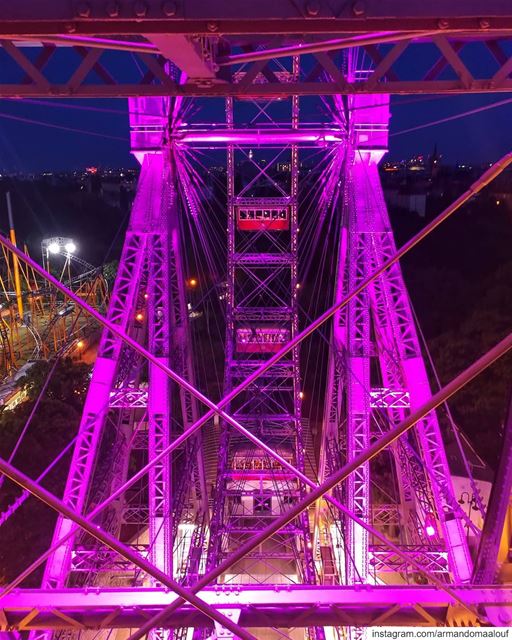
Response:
[0,218,108,380]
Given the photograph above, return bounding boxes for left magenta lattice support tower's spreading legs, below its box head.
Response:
[33,127,207,635]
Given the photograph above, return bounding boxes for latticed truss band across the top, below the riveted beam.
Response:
[0,30,512,99]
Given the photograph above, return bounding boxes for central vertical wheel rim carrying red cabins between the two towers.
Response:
[205,85,315,600]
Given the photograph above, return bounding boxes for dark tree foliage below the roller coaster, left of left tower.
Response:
[0,359,89,586]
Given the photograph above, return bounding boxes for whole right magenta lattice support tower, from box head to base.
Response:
[321,96,471,596]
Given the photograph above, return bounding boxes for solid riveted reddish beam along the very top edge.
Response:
[0,0,512,35]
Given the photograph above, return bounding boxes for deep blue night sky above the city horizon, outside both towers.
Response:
[0,93,512,172]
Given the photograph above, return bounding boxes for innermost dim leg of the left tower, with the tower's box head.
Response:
[130,95,208,579]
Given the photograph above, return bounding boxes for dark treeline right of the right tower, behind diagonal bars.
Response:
[391,185,512,468]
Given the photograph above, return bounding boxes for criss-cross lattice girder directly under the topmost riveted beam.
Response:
[4,33,512,99]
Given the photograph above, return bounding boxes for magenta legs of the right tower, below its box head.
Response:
[346,150,471,582]
